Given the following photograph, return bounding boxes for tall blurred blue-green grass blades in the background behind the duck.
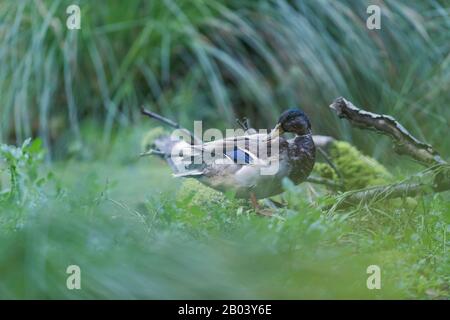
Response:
[0,0,450,158]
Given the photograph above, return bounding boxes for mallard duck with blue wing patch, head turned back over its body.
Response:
[143,109,315,203]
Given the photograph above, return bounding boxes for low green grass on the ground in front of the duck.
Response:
[0,130,450,299]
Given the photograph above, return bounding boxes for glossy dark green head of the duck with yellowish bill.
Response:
[270,109,311,138]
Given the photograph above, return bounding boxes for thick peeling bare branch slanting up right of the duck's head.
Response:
[330,97,446,166]
